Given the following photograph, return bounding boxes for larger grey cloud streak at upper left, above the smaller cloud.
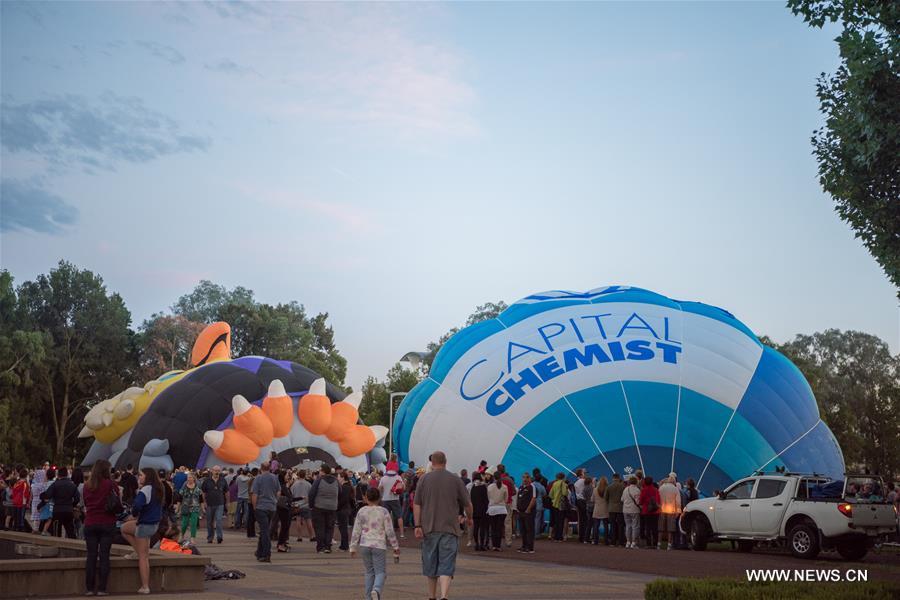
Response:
[0,92,211,170]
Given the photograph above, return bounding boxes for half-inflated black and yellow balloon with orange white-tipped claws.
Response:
[81,322,387,471]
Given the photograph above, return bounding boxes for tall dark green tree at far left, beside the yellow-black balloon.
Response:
[3,261,135,460]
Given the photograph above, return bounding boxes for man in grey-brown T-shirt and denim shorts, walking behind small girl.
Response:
[413,451,472,600]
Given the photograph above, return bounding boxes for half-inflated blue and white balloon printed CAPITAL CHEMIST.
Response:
[393,286,844,494]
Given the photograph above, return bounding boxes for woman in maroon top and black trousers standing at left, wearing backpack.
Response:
[83,459,122,596]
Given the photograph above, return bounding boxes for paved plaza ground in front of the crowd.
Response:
[107,532,657,600]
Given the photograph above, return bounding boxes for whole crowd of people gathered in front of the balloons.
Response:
[0,452,900,600]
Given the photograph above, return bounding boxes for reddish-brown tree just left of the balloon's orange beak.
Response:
[137,313,204,382]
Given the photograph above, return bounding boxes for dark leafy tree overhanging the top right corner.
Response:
[787,0,900,289]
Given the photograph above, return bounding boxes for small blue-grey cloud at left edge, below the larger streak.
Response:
[0,178,78,234]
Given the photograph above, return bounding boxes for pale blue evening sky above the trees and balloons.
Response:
[0,2,900,389]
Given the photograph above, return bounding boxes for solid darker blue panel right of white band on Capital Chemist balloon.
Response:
[738,346,819,451]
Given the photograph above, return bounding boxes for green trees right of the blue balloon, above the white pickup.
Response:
[777,329,900,477]
